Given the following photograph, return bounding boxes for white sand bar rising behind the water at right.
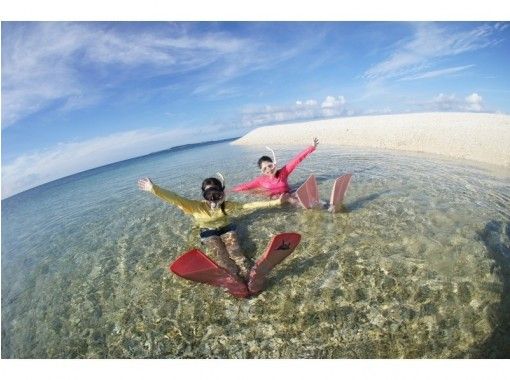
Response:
[232,112,510,167]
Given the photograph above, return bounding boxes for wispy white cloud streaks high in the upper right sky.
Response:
[364,23,503,81]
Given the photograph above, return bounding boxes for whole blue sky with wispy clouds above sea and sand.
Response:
[2,21,510,198]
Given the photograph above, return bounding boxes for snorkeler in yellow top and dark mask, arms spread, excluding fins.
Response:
[138,177,289,279]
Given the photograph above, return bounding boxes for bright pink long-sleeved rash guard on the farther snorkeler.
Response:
[232,146,315,196]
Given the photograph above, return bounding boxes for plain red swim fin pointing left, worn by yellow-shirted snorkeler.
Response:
[169,248,250,298]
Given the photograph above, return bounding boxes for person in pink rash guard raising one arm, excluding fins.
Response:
[231,137,319,203]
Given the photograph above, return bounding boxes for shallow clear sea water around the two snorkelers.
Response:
[2,143,510,358]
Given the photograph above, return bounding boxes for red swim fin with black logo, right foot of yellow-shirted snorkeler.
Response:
[248,232,301,294]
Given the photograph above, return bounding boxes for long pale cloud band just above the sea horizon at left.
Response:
[2,129,203,198]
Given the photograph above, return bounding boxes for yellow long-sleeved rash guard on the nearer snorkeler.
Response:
[152,185,281,228]
